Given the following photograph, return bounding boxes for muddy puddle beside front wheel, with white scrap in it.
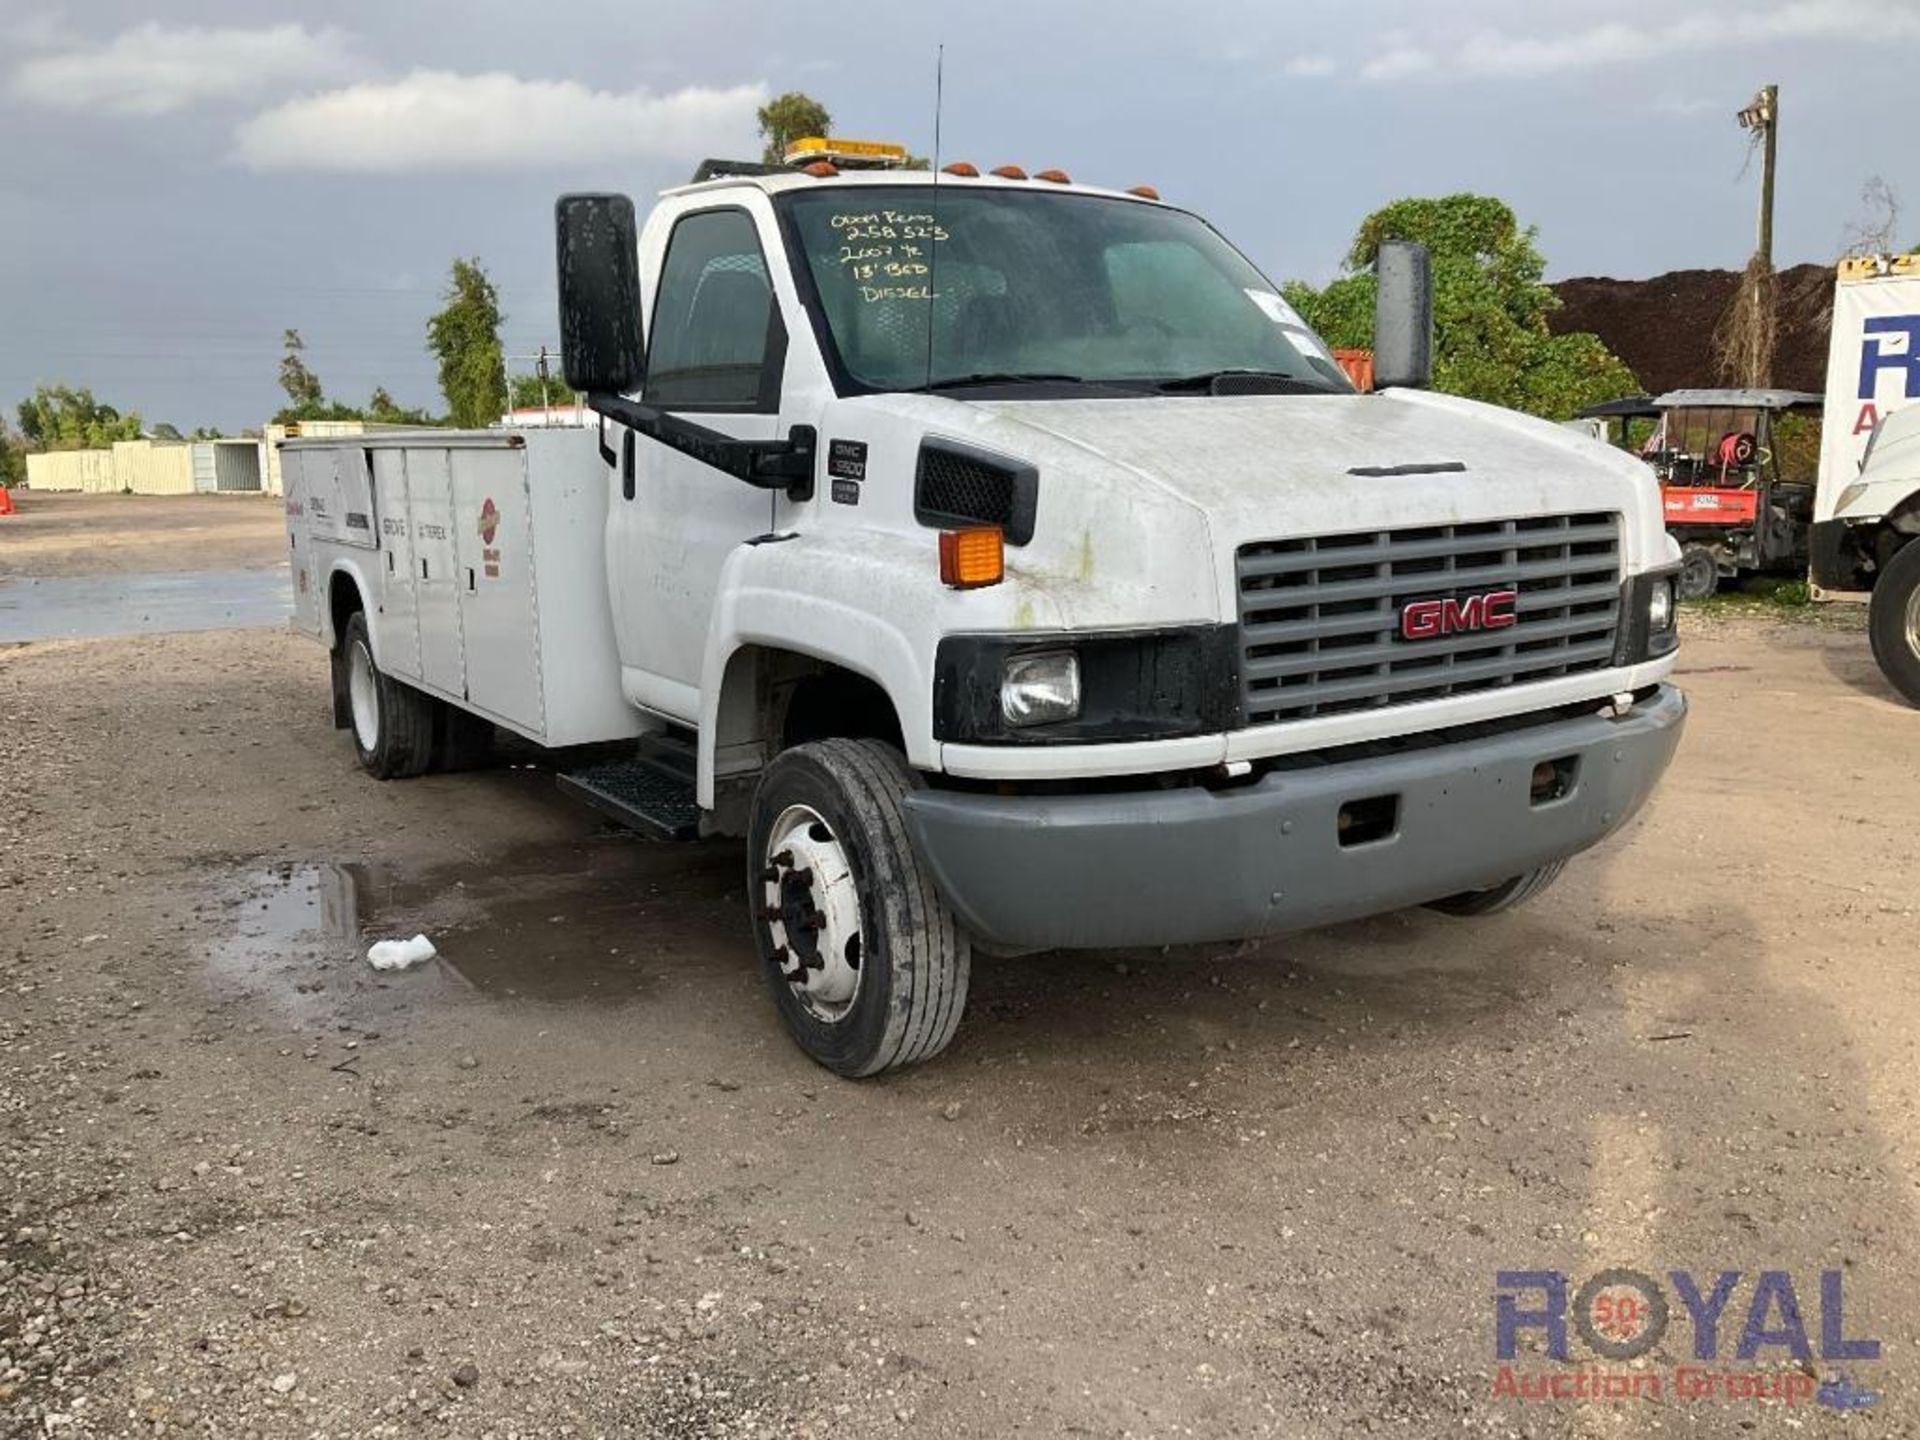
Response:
[207,833,745,1023]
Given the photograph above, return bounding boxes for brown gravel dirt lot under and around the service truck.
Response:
[0,497,1920,1438]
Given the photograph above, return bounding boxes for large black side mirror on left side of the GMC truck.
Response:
[553,194,645,396]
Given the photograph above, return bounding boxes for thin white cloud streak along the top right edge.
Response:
[1361,0,1920,81]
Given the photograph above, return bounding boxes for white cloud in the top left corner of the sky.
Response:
[10,21,353,115]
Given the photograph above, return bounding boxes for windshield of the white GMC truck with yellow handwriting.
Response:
[781,186,1352,401]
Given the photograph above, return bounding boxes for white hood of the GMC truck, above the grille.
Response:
[828,390,1674,626]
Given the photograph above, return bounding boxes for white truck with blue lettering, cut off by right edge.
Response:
[1811,255,1920,705]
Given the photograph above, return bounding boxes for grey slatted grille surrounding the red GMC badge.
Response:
[1236,515,1620,726]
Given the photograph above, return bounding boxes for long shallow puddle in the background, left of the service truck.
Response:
[0,564,294,645]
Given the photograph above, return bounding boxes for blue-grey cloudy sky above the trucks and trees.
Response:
[0,0,1920,430]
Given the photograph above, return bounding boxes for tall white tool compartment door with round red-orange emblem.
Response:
[451,445,547,735]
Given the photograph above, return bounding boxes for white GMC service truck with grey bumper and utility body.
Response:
[284,146,1686,1075]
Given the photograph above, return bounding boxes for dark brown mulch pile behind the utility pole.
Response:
[1548,265,1834,396]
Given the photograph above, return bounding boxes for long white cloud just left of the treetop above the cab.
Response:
[234,69,766,175]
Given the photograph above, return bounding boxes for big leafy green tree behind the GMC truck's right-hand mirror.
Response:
[1286,194,1638,419]
